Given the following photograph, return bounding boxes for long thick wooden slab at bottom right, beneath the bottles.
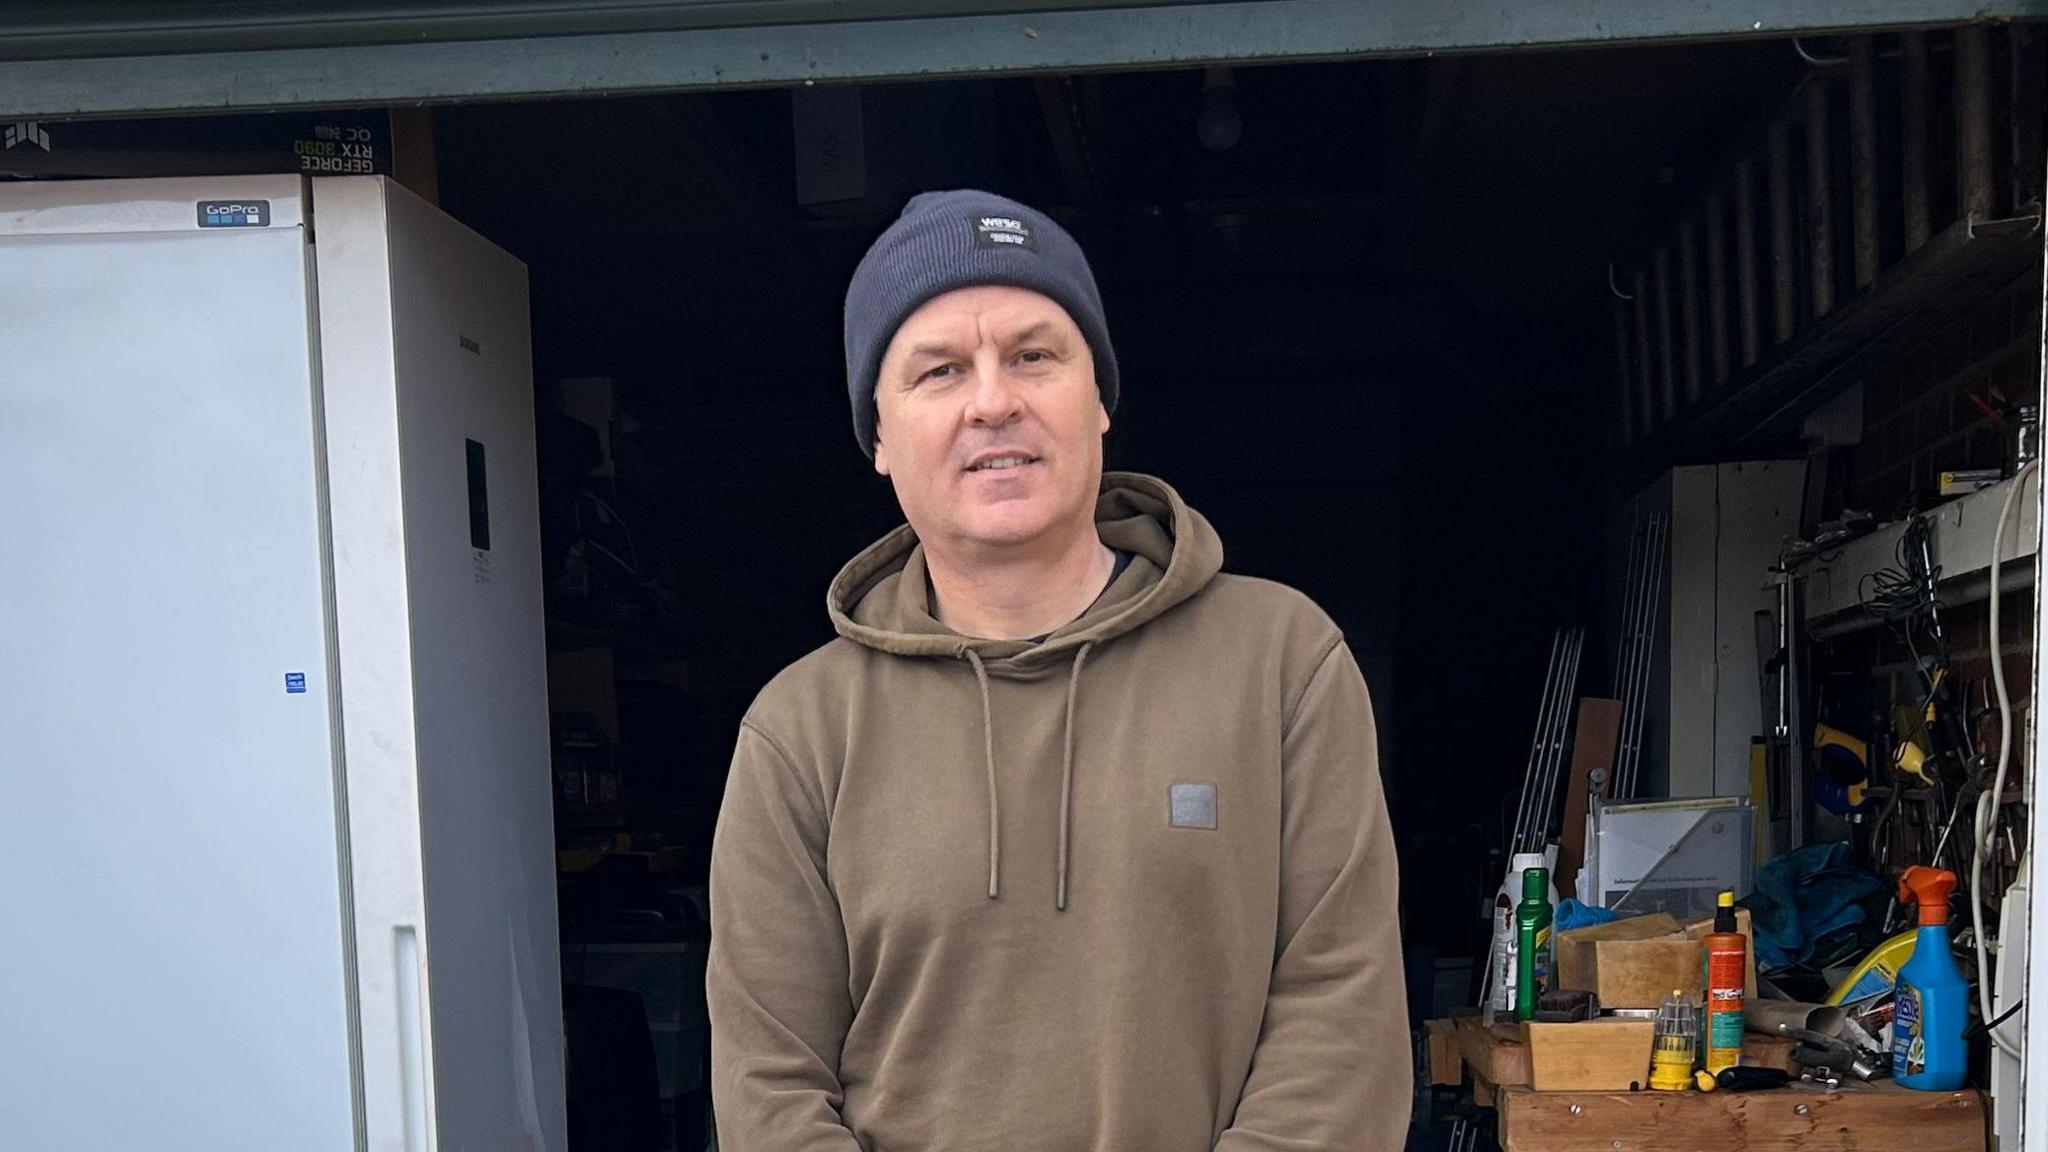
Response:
[1495,1080,1985,1152]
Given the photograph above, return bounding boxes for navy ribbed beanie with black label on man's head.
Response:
[846,189,1116,457]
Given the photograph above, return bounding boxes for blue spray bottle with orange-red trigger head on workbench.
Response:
[1892,865,1970,1093]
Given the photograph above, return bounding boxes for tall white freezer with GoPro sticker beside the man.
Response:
[0,176,565,1152]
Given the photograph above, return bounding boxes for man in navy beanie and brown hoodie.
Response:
[707,191,1409,1152]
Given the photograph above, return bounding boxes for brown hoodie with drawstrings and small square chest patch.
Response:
[707,474,1411,1152]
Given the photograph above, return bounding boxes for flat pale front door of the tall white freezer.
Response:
[0,182,354,1152]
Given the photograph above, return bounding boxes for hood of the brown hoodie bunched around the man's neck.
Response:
[825,471,1223,678]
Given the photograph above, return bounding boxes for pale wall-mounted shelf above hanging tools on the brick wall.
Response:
[1802,463,2042,635]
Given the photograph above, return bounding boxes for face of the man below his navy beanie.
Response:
[874,285,1110,549]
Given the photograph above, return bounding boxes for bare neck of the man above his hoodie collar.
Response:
[926,523,1116,640]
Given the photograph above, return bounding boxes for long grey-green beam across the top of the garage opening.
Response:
[0,0,2048,121]
